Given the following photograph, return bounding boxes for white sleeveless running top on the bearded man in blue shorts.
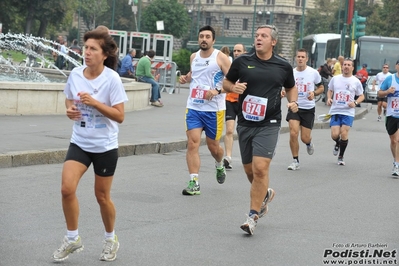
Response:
[187,49,226,112]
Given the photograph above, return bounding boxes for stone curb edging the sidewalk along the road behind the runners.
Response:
[0,103,372,168]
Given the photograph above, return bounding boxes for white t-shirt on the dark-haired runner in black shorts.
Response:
[294,66,321,109]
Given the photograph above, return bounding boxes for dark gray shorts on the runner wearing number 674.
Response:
[237,126,280,164]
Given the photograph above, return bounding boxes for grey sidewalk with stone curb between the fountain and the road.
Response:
[0,86,371,168]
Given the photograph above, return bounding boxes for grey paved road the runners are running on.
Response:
[0,95,399,266]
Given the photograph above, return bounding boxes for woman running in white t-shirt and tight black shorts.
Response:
[53,26,127,261]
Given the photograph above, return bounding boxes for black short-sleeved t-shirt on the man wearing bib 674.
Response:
[226,53,295,127]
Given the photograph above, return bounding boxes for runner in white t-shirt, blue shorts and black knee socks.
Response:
[327,59,364,165]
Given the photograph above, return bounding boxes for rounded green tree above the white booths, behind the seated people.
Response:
[141,0,191,38]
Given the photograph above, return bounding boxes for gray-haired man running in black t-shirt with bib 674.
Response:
[223,25,298,235]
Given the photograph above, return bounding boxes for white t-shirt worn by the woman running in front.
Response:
[64,66,128,153]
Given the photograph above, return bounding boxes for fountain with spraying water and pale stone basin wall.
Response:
[0,33,151,115]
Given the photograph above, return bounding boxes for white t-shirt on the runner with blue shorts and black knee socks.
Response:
[328,74,363,117]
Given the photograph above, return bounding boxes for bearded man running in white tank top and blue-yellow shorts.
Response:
[179,26,231,195]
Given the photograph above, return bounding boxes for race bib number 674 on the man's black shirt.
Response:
[242,95,267,122]
